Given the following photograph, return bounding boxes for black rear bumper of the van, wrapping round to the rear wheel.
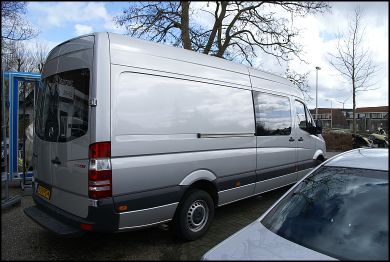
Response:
[24,183,187,234]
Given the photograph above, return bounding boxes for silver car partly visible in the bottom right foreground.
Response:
[202,148,389,260]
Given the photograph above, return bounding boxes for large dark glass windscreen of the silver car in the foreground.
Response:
[261,167,389,260]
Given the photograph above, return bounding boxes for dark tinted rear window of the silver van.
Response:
[35,68,90,142]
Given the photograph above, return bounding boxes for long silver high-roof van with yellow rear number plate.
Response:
[24,33,326,240]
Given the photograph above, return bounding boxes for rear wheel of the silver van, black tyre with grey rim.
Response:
[173,189,214,241]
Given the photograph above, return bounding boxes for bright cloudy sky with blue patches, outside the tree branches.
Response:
[26,2,389,108]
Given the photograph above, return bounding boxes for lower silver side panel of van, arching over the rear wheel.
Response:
[112,148,256,195]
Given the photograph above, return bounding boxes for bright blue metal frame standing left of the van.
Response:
[4,72,41,181]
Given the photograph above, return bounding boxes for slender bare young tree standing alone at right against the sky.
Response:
[329,7,378,136]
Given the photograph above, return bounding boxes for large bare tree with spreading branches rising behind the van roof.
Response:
[114,1,330,65]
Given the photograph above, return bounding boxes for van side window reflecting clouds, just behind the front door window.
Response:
[253,91,291,136]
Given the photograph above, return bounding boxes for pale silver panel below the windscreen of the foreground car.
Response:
[202,220,336,260]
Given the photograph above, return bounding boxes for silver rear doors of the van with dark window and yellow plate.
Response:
[34,36,93,217]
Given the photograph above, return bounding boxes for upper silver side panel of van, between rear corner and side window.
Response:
[112,68,254,157]
